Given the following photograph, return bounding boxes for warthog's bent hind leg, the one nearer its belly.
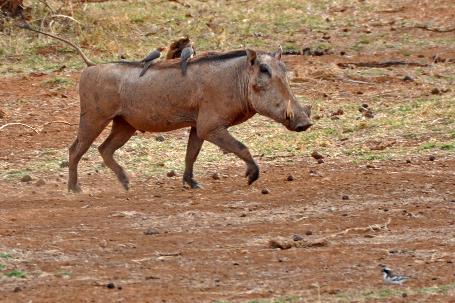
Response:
[98,116,136,190]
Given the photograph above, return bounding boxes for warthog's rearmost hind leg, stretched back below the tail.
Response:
[68,114,111,192]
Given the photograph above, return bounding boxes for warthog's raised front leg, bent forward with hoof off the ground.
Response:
[204,128,259,185]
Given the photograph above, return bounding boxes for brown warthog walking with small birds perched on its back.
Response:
[20,26,311,192]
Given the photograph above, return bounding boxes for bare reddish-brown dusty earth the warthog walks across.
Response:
[0,2,455,302]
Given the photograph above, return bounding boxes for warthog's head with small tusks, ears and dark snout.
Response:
[247,48,311,132]
